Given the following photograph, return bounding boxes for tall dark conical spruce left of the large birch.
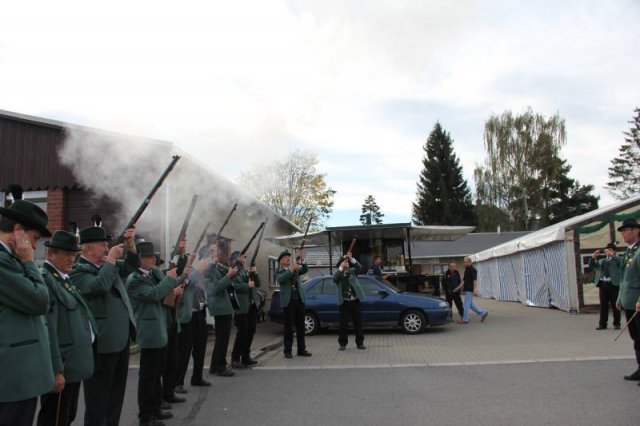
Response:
[412,122,475,225]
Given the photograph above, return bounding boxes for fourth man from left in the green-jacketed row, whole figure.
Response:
[127,241,182,426]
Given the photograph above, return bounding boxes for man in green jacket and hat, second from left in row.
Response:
[37,231,98,426]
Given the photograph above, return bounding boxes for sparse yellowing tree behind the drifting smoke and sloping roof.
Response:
[240,150,336,229]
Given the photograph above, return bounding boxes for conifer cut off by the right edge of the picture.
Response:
[606,108,640,200]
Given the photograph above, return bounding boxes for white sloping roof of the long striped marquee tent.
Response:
[470,195,640,262]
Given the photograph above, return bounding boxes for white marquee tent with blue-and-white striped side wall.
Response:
[470,196,640,312]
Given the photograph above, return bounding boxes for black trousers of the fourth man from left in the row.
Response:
[138,346,167,422]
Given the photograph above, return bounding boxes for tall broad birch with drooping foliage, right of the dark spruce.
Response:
[474,108,566,230]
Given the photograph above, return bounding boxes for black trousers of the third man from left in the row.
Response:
[83,345,129,426]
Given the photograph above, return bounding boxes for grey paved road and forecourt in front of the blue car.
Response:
[72,300,640,426]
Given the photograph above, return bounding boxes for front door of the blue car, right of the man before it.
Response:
[358,276,399,325]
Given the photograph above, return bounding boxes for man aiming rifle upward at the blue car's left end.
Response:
[276,250,311,358]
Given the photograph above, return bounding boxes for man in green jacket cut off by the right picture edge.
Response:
[616,219,640,386]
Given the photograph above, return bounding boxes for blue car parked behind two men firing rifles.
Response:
[269,275,451,335]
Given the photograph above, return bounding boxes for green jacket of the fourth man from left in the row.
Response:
[127,268,178,349]
